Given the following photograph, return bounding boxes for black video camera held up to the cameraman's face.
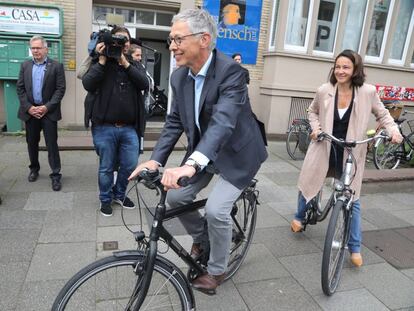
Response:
[88,29,128,59]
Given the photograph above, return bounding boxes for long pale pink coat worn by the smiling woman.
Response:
[298,83,398,202]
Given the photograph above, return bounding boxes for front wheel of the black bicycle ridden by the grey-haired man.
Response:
[52,254,195,311]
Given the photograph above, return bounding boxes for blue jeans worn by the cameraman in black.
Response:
[92,125,139,203]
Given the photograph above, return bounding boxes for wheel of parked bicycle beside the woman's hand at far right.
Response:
[374,138,403,170]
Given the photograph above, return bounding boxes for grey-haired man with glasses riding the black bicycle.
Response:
[130,9,267,294]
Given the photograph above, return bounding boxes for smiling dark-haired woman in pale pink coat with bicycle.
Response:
[291,50,402,267]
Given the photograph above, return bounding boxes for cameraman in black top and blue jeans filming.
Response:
[82,26,148,216]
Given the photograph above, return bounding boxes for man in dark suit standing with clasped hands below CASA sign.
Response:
[17,36,66,191]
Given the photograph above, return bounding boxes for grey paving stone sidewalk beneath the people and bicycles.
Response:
[0,136,414,311]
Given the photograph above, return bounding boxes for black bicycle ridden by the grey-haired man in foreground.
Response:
[52,171,259,311]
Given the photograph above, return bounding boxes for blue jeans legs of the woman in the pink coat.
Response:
[295,192,362,253]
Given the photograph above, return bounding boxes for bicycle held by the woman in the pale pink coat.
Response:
[303,133,388,296]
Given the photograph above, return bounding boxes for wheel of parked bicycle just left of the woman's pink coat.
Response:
[286,125,310,160]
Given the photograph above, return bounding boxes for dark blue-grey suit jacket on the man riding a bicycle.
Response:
[151,50,267,189]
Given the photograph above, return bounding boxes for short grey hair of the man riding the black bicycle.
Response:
[172,9,217,50]
